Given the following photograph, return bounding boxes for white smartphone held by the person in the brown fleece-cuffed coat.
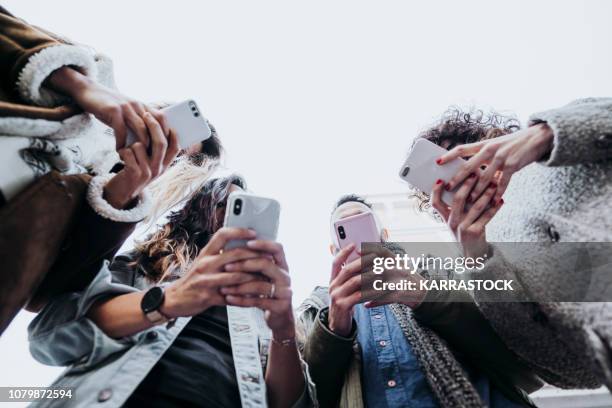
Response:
[125,99,212,149]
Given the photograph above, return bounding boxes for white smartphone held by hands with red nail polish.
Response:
[399,139,465,205]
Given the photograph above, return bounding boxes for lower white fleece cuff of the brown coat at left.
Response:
[87,173,152,222]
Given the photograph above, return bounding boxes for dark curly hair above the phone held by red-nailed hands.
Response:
[413,106,521,211]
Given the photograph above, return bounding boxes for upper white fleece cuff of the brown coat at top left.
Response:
[17,44,98,107]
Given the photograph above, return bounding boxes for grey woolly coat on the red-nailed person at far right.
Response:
[475,98,612,389]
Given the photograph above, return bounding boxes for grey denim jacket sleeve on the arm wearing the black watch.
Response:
[28,262,138,367]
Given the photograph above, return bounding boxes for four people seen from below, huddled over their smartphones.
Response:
[0,8,612,408]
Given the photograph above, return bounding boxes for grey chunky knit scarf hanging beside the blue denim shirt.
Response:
[390,304,484,408]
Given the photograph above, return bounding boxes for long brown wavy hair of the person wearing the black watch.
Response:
[134,174,246,283]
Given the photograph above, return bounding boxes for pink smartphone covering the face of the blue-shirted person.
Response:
[334,212,380,263]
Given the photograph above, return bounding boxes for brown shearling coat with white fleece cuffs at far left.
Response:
[0,7,150,334]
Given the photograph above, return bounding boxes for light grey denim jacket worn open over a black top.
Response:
[28,255,318,408]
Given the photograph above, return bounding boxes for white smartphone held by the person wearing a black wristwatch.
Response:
[223,191,280,250]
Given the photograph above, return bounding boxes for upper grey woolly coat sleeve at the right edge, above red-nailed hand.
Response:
[529,98,612,166]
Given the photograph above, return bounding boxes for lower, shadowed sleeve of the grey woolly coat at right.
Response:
[473,246,602,388]
